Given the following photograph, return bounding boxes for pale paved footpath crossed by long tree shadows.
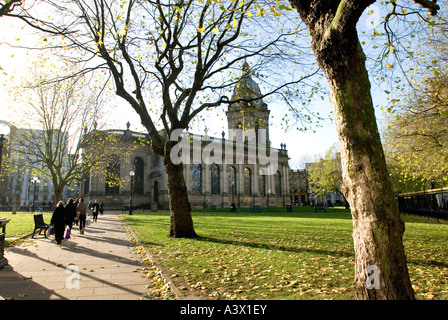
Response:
[0,212,149,300]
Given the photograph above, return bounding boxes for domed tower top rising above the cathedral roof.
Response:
[226,61,270,146]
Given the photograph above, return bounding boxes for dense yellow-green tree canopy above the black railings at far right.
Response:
[383,24,448,192]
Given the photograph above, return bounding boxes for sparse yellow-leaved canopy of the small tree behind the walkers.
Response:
[6,58,133,201]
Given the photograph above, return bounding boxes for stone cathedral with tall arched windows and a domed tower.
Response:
[81,63,290,210]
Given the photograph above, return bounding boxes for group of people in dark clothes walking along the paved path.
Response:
[50,198,104,244]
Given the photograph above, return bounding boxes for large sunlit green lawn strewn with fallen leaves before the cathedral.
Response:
[123,208,448,299]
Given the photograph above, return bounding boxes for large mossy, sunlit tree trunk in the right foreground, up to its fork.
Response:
[291,0,414,299]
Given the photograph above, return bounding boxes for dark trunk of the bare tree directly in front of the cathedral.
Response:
[164,141,197,238]
